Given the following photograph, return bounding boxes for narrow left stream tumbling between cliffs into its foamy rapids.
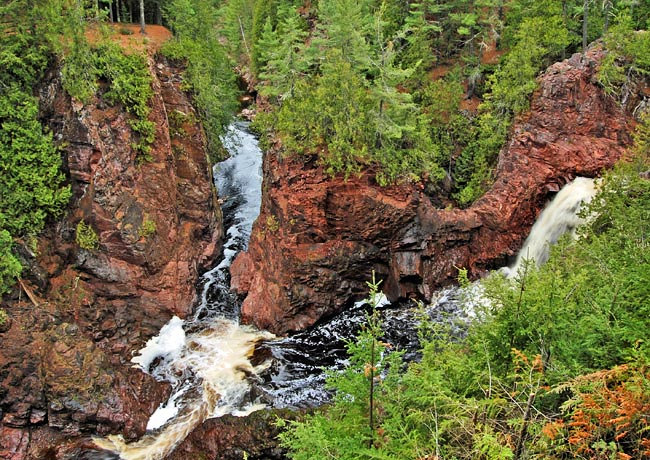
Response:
[94,123,274,460]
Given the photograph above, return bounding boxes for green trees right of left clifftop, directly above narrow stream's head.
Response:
[162,0,238,160]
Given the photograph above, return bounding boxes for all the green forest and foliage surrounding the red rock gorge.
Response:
[0,0,650,460]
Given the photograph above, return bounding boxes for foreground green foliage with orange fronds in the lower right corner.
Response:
[281,142,650,460]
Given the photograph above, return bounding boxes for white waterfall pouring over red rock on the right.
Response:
[504,177,596,277]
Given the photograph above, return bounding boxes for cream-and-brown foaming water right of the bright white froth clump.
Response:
[93,320,274,460]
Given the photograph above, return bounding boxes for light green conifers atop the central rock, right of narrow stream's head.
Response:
[256,0,444,185]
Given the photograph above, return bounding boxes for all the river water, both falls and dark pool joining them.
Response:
[95,130,596,460]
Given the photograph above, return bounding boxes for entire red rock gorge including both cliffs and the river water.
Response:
[0,19,647,460]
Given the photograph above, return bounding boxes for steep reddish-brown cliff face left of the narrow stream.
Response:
[0,53,222,459]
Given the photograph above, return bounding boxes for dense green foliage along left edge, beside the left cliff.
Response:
[0,1,70,295]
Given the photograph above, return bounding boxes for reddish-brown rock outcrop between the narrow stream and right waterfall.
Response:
[231,46,633,333]
